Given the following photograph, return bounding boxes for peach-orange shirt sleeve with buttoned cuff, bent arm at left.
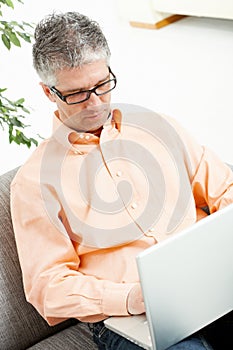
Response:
[11,175,134,325]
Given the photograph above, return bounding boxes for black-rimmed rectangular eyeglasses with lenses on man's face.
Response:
[50,67,117,105]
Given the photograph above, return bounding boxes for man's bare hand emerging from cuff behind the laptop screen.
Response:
[127,283,145,315]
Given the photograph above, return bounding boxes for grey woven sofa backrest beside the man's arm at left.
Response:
[0,169,84,350]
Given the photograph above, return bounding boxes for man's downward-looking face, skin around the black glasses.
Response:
[42,61,111,132]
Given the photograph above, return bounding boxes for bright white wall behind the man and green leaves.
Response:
[0,0,233,173]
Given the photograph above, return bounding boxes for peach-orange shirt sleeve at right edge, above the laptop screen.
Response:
[163,115,233,214]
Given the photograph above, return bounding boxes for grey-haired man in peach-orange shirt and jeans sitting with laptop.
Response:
[11,12,233,350]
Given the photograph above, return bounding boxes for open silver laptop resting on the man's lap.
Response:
[105,204,233,350]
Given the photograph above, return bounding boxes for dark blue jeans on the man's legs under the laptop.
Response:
[89,322,212,350]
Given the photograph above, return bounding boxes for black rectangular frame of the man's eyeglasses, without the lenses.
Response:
[49,67,117,105]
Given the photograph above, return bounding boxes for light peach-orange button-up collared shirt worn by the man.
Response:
[11,108,233,325]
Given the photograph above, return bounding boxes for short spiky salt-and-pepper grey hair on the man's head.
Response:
[32,12,111,86]
